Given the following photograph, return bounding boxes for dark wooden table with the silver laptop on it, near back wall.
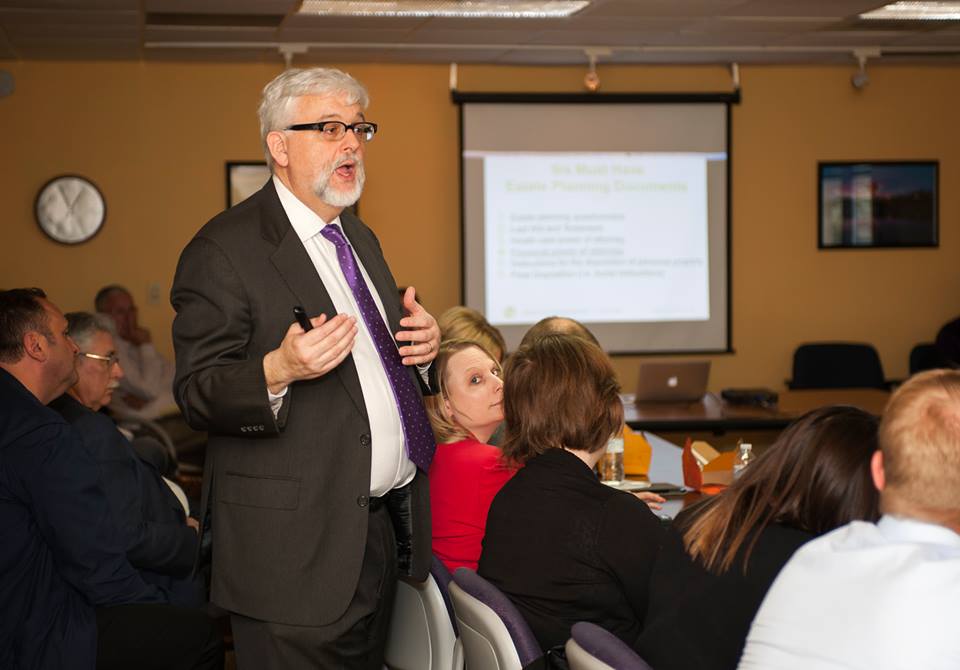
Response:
[622,388,890,434]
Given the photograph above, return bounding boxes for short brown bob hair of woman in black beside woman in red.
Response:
[503,335,623,463]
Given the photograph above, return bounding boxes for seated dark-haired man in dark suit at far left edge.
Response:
[0,289,223,670]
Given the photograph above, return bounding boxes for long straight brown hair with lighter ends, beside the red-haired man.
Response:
[684,407,879,572]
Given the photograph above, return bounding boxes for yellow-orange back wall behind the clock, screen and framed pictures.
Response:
[0,61,960,389]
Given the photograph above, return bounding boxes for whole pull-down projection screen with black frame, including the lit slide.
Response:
[454,94,732,353]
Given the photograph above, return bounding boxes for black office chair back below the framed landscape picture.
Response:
[787,342,890,390]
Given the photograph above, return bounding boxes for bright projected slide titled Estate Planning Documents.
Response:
[484,152,711,325]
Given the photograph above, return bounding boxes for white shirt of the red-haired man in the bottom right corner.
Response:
[739,516,960,670]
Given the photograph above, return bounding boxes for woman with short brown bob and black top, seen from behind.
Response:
[478,335,663,650]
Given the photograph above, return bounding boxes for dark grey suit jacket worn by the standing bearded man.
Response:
[171,181,430,626]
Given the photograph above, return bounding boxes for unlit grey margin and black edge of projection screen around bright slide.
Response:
[454,93,739,354]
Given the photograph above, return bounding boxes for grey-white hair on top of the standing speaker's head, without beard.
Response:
[257,67,370,172]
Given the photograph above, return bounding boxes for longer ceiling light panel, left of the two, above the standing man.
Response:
[298,0,590,19]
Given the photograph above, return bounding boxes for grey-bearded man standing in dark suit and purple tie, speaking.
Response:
[171,68,440,670]
